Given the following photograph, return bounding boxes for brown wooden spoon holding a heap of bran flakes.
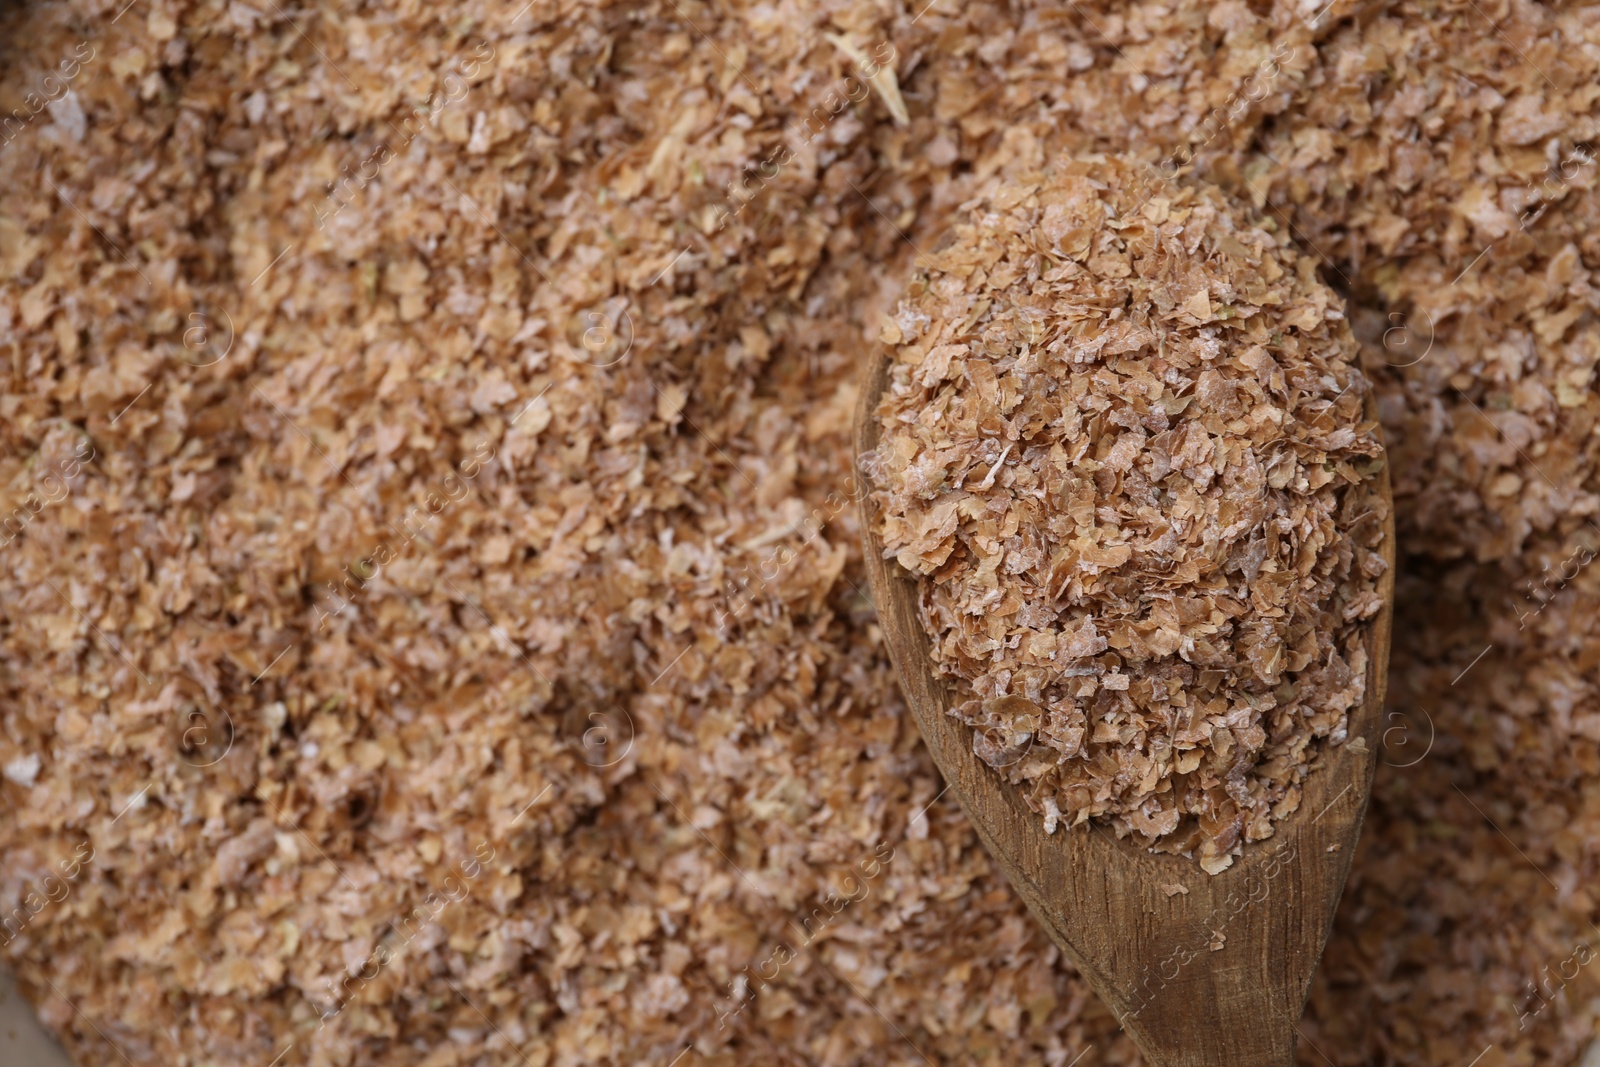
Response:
[856,346,1395,1067]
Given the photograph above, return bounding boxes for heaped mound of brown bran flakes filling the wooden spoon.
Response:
[869,157,1387,873]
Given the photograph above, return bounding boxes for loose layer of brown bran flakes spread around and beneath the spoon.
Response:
[0,0,1600,1067]
